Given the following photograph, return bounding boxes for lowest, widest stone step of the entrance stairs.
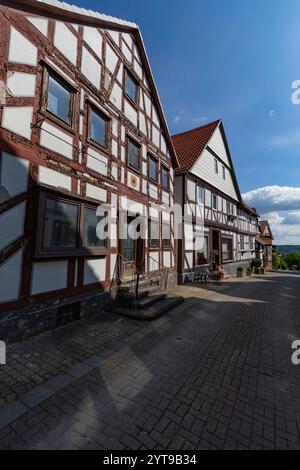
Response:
[105,297,184,320]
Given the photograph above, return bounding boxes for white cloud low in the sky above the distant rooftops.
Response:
[242,186,300,245]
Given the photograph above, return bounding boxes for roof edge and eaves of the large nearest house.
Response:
[0,0,179,168]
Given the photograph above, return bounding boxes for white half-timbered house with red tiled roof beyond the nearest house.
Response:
[172,120,258,279]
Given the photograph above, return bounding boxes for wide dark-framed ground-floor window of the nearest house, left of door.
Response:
[36,190,108,257]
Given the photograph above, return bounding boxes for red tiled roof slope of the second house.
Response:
[171,119,221,173]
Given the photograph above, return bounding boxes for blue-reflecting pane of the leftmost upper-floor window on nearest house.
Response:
[47,75,72,123]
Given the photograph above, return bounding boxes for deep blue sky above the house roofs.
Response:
[68,0,300,244]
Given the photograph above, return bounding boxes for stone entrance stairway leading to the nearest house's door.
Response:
[105,258,184,320]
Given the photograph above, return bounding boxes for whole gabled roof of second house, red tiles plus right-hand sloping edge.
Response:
[172,119,243,200]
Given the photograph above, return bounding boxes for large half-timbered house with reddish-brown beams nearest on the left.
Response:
[0,0,177,339]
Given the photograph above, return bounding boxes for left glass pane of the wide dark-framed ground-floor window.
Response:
[43,199,78,248]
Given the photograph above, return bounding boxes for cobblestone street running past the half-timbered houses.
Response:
[0,273,300,450]
